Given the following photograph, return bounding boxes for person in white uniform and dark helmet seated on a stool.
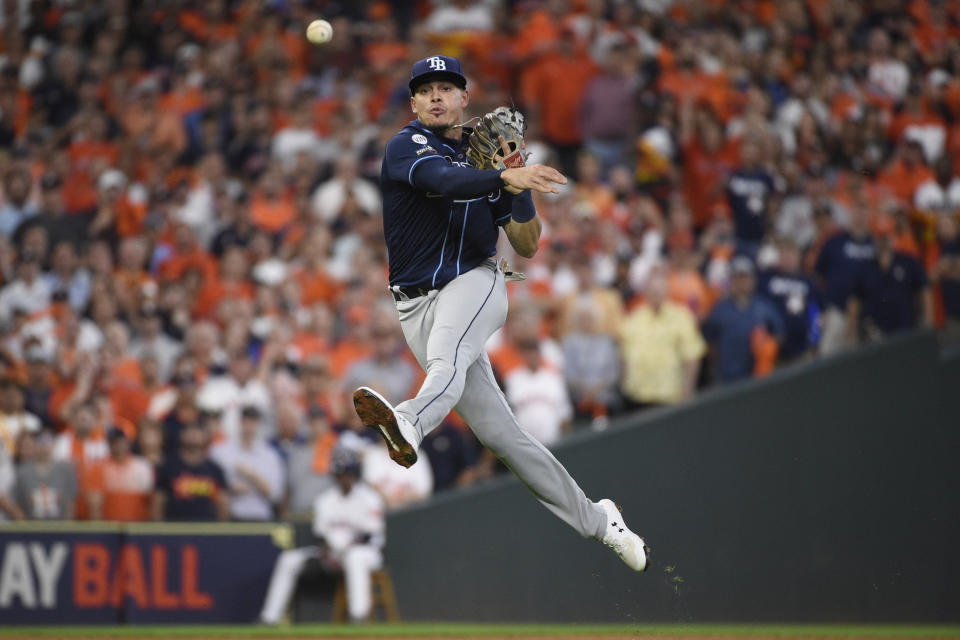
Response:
[260,447,386,624]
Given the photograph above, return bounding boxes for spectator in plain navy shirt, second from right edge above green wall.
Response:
[847,224,933,342]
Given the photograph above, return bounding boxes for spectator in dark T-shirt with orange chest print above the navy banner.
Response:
[150,425,230,522]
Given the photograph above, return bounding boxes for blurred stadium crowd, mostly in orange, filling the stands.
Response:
[0,0,960,520]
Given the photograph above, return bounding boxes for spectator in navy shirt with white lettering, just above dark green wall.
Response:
[757,236,823,364]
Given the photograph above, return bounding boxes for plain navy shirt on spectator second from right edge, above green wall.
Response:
[856,253,927,333]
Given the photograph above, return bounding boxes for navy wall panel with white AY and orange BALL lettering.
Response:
[0,522,293,629]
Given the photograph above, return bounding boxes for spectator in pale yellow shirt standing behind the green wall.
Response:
[620,266,706,407]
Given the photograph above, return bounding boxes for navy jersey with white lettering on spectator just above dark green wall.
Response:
[757,269,823,358]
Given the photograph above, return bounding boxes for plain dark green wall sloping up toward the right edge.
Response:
[362,334,960,622]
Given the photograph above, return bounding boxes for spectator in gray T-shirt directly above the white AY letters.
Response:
[13,429,77,520]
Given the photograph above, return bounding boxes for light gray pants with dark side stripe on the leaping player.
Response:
[395,259,607,538]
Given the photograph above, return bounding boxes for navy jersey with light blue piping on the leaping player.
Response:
[380,120,533,289]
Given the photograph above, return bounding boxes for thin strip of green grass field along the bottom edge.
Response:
[0,623,960,640]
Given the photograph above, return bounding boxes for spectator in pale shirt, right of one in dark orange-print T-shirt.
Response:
[210,406,284,521]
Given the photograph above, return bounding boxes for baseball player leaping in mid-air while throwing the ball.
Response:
[353,55,650,571]
